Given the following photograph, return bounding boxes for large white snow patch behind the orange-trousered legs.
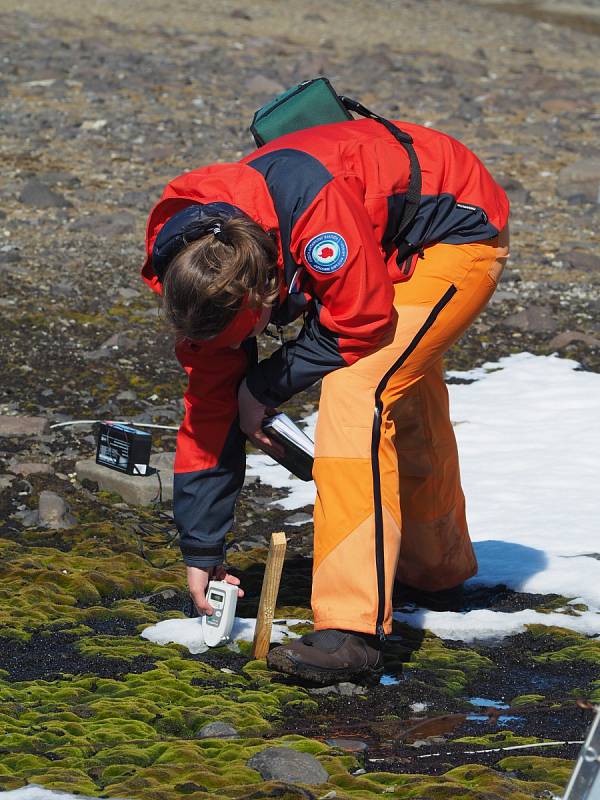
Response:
[243,353,600,640]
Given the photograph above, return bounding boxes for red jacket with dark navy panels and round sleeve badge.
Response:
[143,119,508,567]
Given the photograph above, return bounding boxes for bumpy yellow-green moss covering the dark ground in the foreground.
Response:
[0,494,598,800]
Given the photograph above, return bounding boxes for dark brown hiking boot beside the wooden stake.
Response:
[267,629,383,685]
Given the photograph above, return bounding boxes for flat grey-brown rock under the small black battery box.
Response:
[75,453,175,506]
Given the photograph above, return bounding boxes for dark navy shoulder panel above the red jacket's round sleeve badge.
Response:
[248,148,333,286]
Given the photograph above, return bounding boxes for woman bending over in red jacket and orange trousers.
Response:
[143,119,509,682]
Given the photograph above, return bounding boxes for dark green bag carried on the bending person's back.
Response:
[250,78,352,147]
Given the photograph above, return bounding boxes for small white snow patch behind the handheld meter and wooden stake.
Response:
[141,617,306,653]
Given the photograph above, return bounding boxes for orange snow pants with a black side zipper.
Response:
[312,228,508,633]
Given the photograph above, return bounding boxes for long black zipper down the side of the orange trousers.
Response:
[371,284,457,640]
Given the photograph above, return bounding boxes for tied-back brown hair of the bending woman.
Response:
[163,217,279,340]
